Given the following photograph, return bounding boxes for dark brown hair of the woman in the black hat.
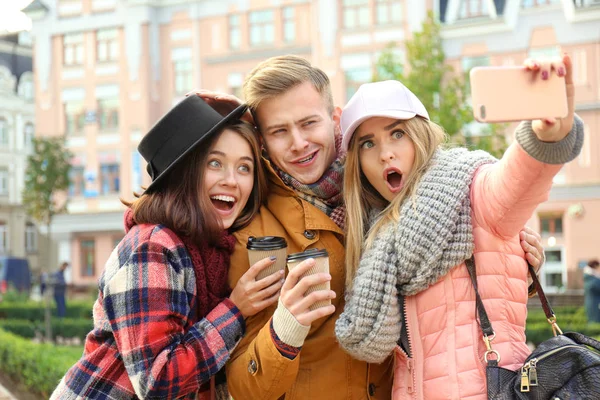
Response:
[121,121,268,244]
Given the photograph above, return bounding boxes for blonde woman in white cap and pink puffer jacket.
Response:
[335,55,583,400]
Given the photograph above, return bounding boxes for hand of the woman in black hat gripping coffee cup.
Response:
[229,257,285,318]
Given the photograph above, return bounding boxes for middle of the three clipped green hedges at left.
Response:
[0,318,94,342]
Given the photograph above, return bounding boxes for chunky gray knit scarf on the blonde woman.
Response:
[335,148,495,362]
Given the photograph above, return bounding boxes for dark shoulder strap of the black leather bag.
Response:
[465,255,562,363]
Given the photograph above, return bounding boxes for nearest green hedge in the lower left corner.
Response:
[0,329,83,399]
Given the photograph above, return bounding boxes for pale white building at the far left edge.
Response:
[0,32,42,274]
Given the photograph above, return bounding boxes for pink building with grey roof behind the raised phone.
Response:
[439,0,600,292]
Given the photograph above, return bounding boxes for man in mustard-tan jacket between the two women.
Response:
[191,56,542,400]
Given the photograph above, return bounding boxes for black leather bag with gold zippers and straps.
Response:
[466,257,600,400]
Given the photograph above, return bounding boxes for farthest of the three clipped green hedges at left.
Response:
[0,300,94,321]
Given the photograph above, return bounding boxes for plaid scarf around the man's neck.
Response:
[272,135,346,229]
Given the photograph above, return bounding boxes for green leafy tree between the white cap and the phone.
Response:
[373,12,507,157]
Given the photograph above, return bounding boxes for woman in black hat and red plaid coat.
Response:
[51,96,283,400]
